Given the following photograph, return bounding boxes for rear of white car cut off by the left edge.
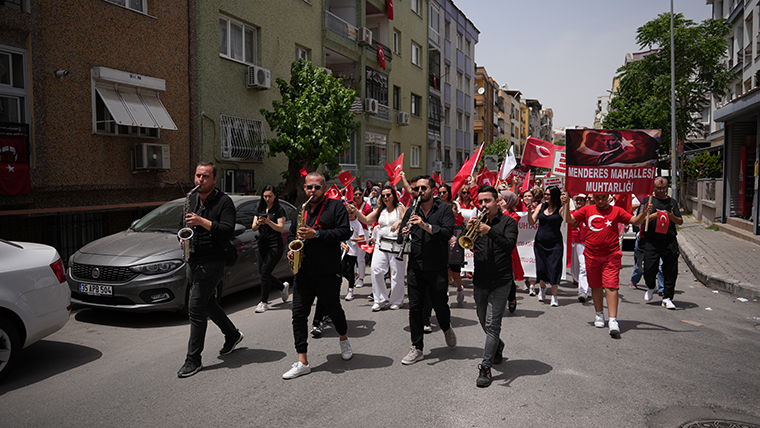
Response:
[0,239,71,380]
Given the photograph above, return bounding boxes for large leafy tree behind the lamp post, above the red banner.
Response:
[603,13,732,153]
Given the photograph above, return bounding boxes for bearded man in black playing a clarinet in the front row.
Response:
[398,175,457,365]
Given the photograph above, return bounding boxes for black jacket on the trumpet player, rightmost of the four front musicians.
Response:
[472,212,517,289]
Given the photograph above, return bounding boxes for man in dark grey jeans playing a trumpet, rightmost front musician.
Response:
[467,185,517,387]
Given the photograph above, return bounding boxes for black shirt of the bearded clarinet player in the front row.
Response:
[398,198,454,272]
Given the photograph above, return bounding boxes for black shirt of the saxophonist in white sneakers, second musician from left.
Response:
[288,198,351,276]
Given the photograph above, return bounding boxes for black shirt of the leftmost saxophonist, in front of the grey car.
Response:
[188,188,235,263]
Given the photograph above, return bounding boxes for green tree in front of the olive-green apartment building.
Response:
[261,60,360,202]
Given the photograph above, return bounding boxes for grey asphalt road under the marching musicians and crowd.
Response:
[0,247,760,427]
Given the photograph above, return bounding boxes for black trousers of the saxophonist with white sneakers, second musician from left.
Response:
[293,273,348,354]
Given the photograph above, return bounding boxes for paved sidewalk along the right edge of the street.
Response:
[678,215,760,300]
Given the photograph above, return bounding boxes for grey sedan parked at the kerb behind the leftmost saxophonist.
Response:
[68,195,295,312]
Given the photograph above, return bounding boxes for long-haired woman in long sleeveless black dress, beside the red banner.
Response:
[528,186,565,306]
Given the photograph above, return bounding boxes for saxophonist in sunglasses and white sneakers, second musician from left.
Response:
[282,172,353,379]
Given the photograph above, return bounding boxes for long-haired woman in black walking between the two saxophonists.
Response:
[252,184,290,313]
